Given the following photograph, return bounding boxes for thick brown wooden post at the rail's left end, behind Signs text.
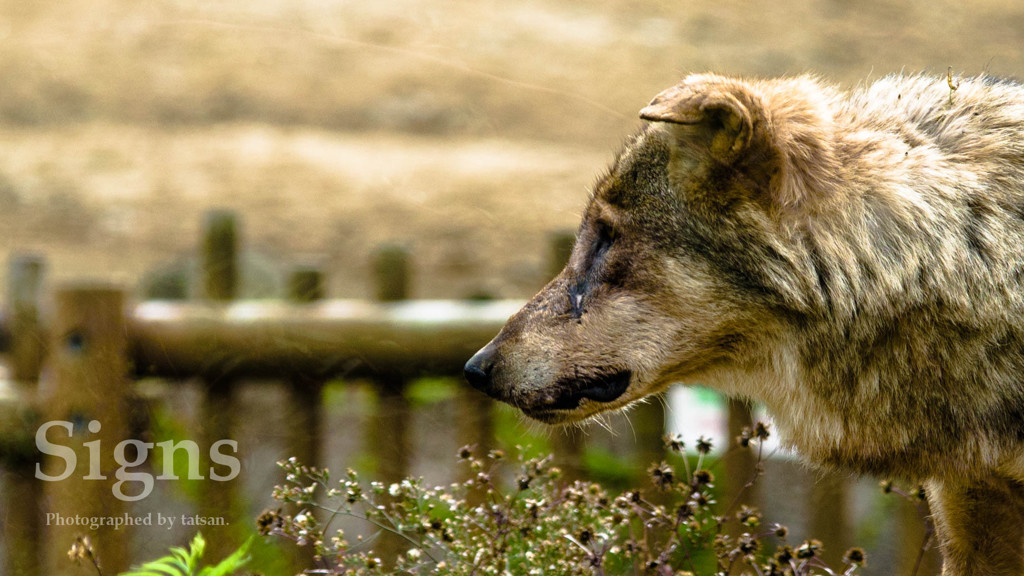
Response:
[40,287,132,574]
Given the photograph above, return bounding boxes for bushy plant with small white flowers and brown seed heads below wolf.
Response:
[257,424,864,576]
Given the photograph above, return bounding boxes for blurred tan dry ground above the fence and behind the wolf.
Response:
[0,0,1024,297]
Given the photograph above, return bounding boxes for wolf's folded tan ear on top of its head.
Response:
[640,77,754,163]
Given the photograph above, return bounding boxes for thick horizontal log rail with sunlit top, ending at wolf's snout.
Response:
[128,300,523,378]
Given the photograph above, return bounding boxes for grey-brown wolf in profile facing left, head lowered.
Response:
[465,74,1024,576]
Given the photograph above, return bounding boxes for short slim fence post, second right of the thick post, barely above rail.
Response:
[286,266,324,574]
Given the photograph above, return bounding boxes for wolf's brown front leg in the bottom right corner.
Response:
[927,476,1024,576]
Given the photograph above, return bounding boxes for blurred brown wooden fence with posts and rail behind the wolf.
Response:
[0,211,937,576]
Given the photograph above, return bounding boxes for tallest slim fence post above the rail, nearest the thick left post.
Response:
[198,210,242,558]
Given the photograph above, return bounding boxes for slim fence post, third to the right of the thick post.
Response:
[369,246,413,560]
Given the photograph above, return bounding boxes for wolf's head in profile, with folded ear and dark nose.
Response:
[465,75,838,423]
